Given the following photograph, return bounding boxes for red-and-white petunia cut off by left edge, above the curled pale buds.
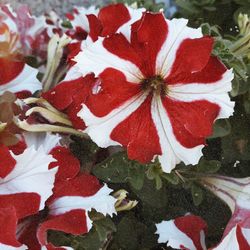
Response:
[0,58,42,94]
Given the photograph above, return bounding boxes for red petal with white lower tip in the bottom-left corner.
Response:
[0,206,28,250]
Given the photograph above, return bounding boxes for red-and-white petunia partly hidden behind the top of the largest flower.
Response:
[67,3,145,43]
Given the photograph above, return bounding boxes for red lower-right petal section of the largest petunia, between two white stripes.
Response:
[162,98,220,148]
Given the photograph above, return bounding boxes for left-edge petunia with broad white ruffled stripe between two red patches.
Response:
[0,145,57,219]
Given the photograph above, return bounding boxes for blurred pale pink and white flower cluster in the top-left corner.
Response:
[0,4,62,59]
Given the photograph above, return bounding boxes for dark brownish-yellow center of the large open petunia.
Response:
[141,75,168,96]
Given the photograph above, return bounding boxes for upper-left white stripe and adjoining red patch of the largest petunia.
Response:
[74,34,142,83]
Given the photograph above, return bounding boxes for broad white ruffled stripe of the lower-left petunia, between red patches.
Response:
[0,147,57,210]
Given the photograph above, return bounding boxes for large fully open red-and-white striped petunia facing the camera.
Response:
[75,12,234,172]
